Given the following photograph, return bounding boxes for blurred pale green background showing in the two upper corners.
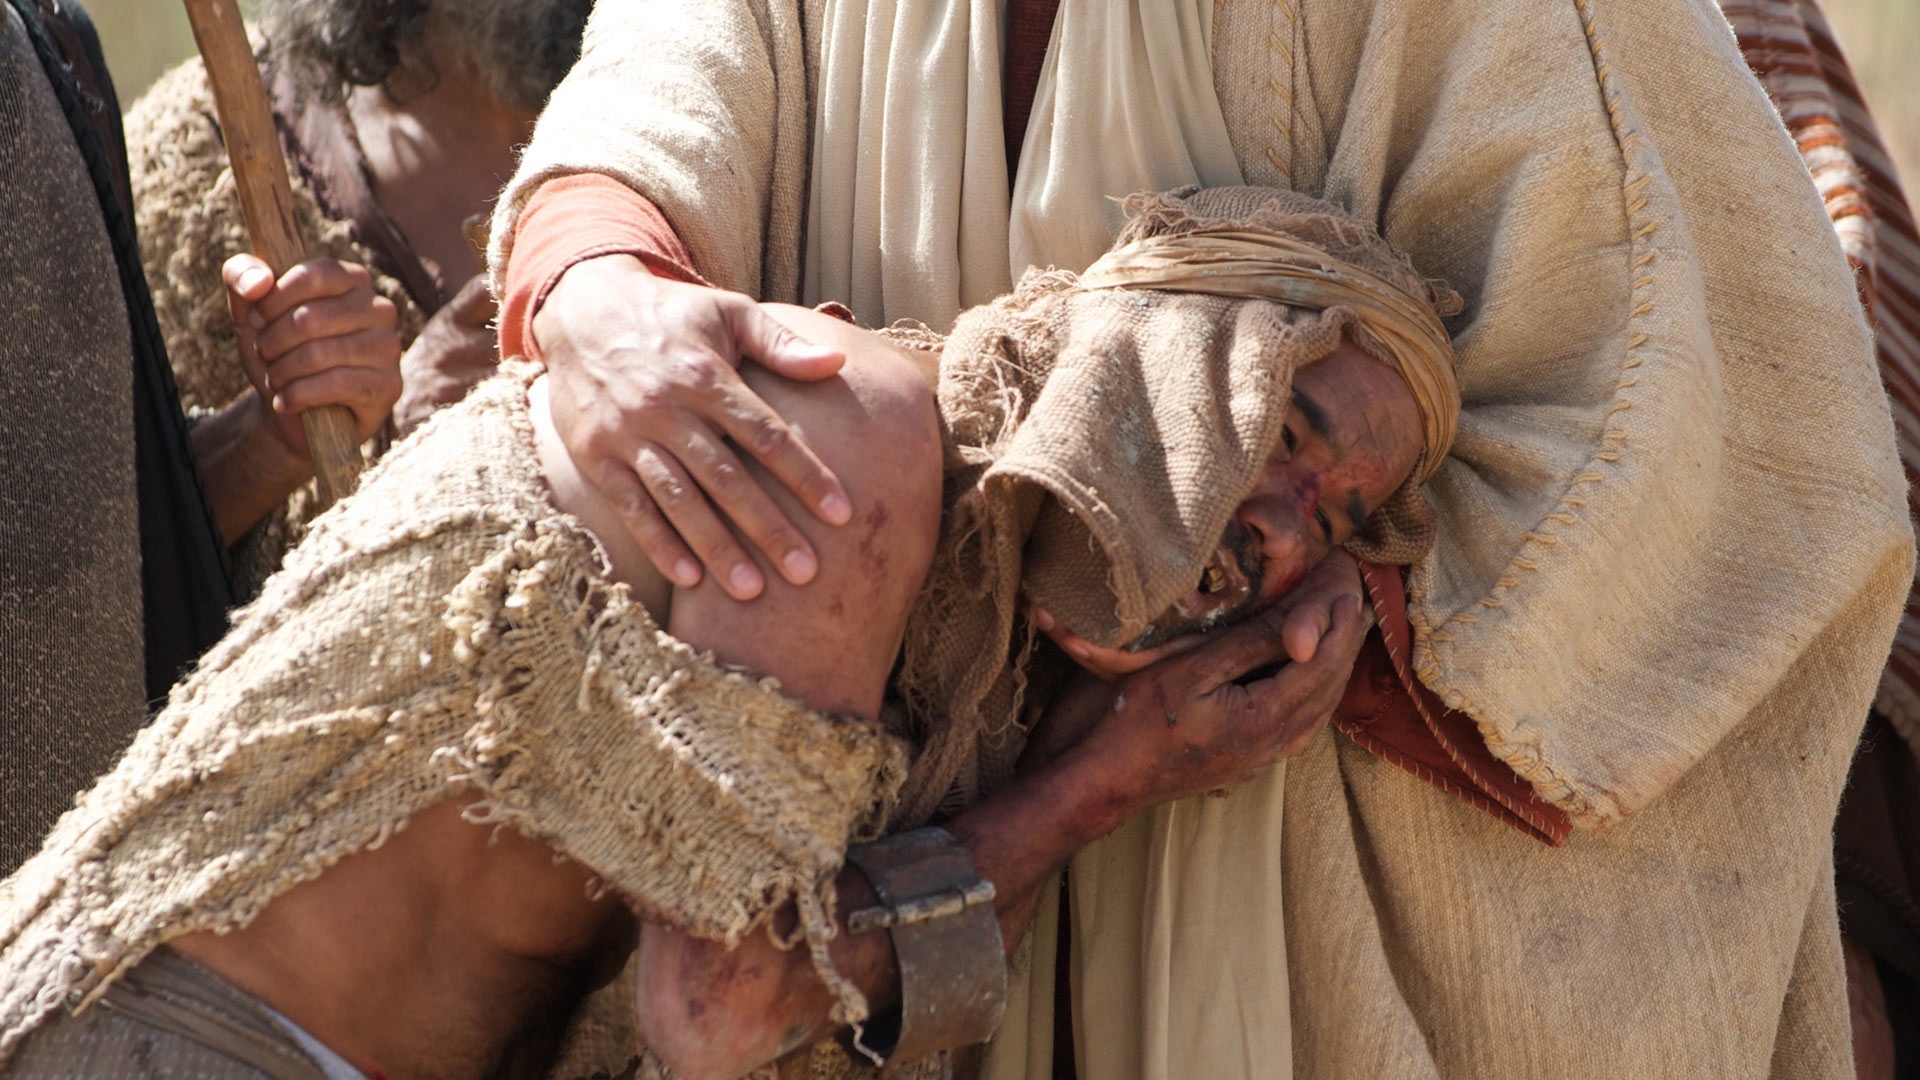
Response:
[71,0,1920,198]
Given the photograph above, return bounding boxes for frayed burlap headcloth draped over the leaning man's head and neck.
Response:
[895,188,1452,822]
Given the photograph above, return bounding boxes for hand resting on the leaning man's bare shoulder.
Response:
[534,256,852,600]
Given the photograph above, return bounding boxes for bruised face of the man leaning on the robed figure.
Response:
[1127,342,1423,651]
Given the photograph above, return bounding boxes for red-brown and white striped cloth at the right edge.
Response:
[1720,0,1920,753]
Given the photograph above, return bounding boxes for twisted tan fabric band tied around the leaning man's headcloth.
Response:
[1079,231,1459,484]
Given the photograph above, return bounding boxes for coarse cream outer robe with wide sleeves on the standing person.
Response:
[495,0,1912,1080]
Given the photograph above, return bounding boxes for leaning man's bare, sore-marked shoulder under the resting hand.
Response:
[670,307,941,715]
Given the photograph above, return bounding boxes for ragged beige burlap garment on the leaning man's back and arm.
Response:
[0,365,904,1063]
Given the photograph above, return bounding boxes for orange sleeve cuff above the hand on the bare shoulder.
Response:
[499,173,707,359]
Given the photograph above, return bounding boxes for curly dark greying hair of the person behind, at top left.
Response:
[261,0,593,110]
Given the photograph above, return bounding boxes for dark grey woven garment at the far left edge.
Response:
[0,8,146,874]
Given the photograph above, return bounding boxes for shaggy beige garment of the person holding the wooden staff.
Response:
[125,60,426,598]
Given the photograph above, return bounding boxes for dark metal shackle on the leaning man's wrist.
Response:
[847,828,1006,1061]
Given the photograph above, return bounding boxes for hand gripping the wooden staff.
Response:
[221,256,399,461]
